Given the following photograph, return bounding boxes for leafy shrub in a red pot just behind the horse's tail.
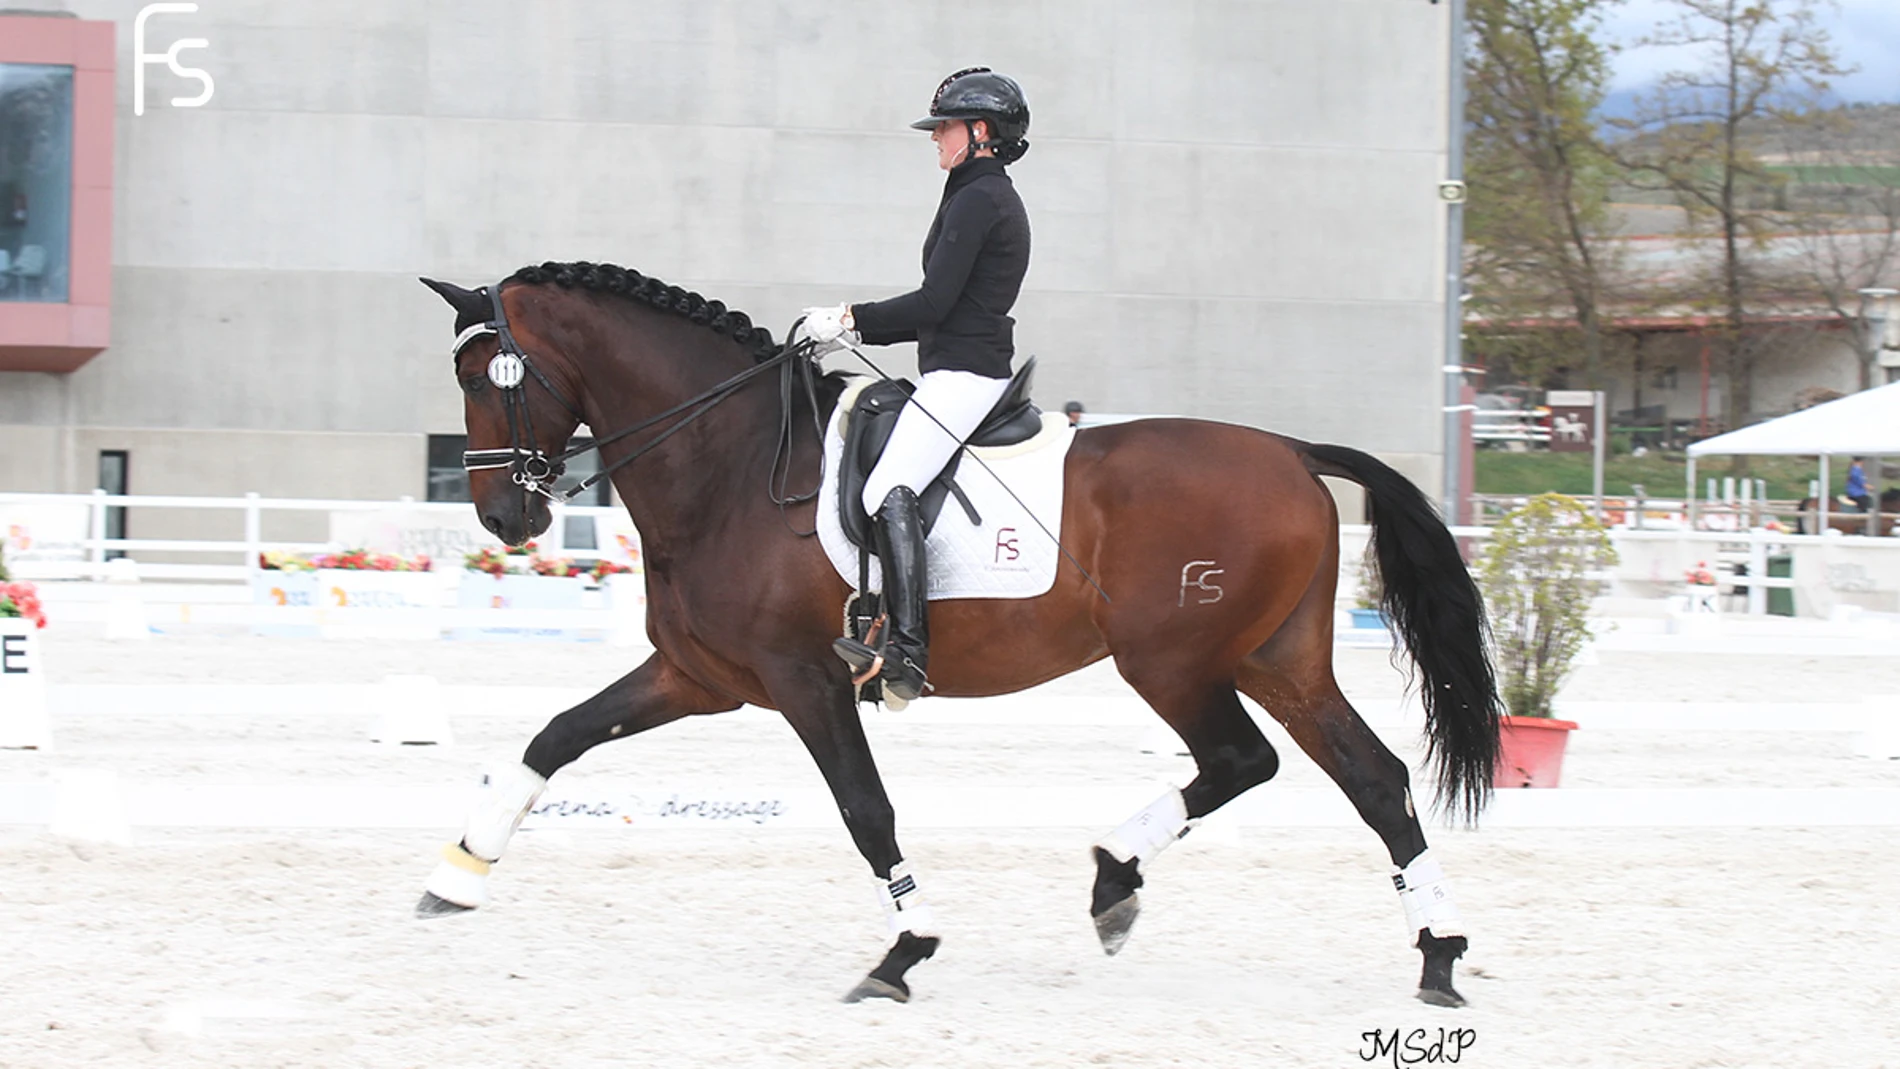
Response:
[1478,494,1617,786]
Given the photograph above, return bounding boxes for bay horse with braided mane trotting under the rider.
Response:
[416,262,1499,1006]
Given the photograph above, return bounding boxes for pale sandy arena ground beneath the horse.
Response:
[0,636,1900,1069]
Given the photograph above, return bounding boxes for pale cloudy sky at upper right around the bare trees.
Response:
[1604,0,1900,104]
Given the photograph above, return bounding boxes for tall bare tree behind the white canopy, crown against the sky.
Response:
[1617,0,1845,434]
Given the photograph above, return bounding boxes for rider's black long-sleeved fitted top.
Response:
[851,156,1030,378]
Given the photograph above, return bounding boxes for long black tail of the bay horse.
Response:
[1302,442,1501,820]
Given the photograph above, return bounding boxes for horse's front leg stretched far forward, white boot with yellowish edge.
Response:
[416,653,739,917]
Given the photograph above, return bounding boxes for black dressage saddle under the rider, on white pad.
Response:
[838,357,1043,549]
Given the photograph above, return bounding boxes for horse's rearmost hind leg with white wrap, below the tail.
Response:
[1239,660,1467,1006]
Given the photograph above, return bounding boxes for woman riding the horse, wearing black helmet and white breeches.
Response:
[804,66,1030,701]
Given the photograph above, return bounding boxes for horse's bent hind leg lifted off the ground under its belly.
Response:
[1089,657,1281,953]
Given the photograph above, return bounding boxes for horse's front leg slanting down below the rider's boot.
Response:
[768,665,939,1003]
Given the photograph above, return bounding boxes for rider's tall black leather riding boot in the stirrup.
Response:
[832,486,931,701]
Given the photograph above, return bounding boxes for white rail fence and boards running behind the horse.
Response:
[0,492,1900,644]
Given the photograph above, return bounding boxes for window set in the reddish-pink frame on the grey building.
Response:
[0,63,72,304]
